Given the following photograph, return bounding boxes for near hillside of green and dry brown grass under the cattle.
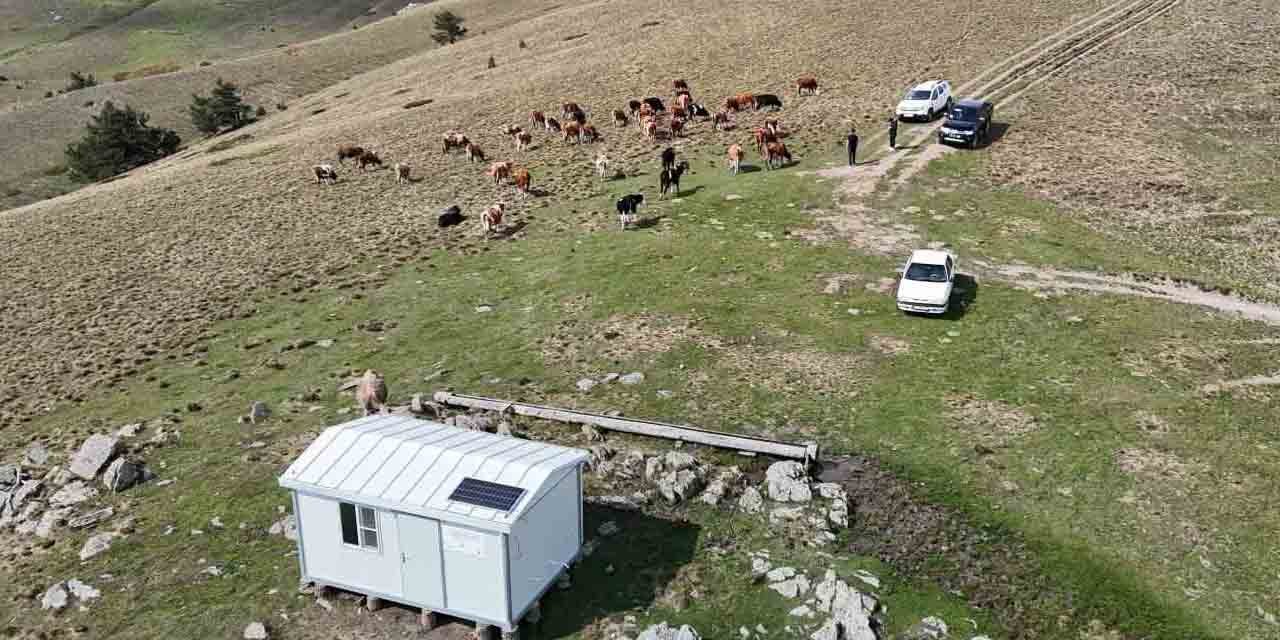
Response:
[0,1,1280,640]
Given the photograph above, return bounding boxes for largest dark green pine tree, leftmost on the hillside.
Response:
[67,101,180,180]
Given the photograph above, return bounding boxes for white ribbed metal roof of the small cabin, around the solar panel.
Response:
[280,415,588,530]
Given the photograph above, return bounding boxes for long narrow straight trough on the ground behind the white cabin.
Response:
[435,392,819,465]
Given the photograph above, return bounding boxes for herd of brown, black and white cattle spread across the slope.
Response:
[312,76,819,236]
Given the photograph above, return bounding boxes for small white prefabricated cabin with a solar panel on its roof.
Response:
[279,415,588,632]
